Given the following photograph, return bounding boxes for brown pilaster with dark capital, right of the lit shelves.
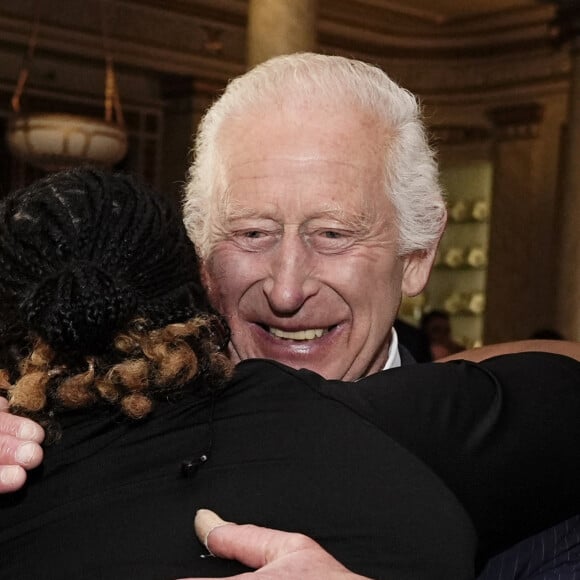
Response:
[484,103,556,343]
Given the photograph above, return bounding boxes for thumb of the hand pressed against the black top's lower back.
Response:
[195,510,319,568]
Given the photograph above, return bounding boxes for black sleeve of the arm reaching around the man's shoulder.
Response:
[312,353,580,555]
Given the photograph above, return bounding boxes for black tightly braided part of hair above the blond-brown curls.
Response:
[0,168,220,354]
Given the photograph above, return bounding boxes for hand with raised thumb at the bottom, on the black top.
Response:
[178,510,368,580]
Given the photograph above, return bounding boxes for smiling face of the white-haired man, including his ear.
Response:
[204,108,432,380]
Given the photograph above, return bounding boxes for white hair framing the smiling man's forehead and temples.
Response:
[184,53,446,259]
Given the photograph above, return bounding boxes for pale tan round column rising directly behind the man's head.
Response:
[247,0,318,68]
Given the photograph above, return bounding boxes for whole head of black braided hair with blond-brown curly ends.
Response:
[0,168,231,440]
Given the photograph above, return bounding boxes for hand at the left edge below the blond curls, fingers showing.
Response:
[0,397,44,493]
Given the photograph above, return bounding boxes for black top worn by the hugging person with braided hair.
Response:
[0,354,580,580]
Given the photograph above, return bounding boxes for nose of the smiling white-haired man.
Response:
[263,234,319,316]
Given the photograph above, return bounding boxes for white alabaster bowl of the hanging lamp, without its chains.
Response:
[7,113,127,171]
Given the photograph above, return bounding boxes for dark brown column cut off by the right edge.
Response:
[556,0,580,341]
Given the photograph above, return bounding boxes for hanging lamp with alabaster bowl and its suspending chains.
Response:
[7,0,127,171]
